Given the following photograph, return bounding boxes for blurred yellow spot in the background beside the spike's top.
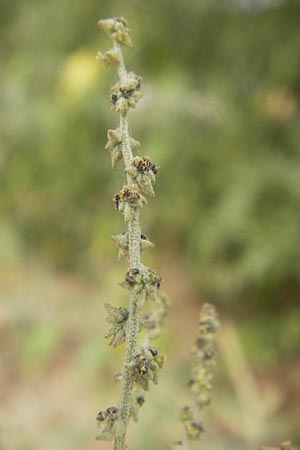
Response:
[59,49,102,97]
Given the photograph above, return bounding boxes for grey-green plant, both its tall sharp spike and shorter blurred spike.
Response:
[96,18,219,450]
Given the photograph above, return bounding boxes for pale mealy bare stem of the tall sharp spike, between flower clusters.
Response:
[113,42,141,450]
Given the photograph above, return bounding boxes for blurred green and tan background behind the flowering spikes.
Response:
[0,0,300,450]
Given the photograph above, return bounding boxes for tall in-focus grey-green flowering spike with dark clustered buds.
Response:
[97,17,166,450]
